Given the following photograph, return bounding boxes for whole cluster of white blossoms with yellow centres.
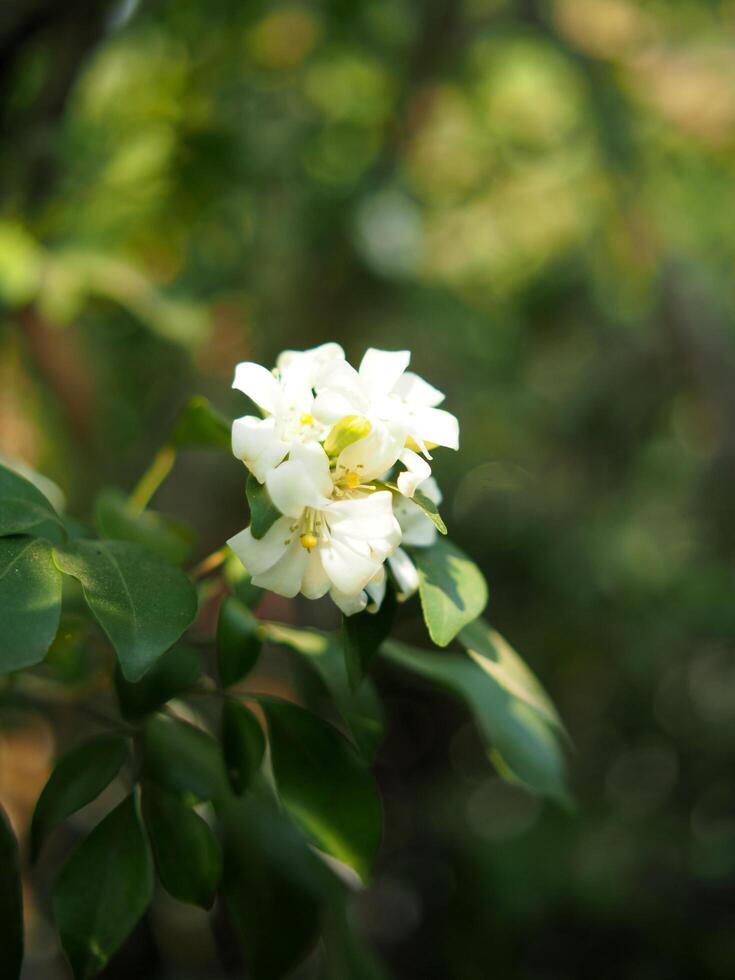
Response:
[228,344,459,615]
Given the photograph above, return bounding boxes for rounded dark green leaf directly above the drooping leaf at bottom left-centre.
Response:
[143,715,227,801]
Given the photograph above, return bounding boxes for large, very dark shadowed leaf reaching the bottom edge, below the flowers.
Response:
[222,794,328,980]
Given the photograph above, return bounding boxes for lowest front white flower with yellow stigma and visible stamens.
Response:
[228,437,401,615]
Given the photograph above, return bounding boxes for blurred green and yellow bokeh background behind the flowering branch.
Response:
[0,0,735,980]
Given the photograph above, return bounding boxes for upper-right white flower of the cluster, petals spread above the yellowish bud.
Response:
[314,347,459,482]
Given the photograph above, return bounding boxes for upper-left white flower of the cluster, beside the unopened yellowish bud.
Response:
[232,344,344,483]
